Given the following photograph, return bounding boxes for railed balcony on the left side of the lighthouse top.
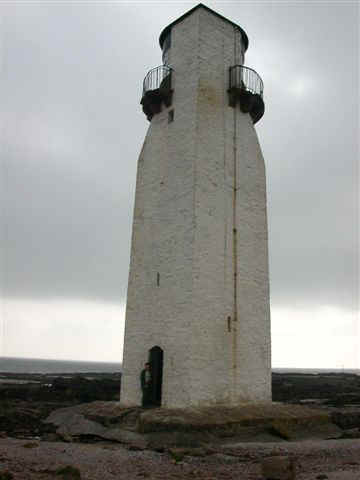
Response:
[140,65,173,121]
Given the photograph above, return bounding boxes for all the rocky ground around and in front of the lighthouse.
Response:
[0,374,360,480]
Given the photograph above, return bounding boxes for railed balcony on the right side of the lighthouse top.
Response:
[228,65,265,123]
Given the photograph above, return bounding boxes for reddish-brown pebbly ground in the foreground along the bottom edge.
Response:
[0,438,360,480]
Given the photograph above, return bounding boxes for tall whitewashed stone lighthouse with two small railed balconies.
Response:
[121,4,271,408]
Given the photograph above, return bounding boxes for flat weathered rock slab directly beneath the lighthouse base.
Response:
[45,402,342,446]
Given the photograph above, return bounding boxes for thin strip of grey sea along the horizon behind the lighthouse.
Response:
[0,357,360,375]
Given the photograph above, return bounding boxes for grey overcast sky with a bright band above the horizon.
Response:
[0,0,360,368]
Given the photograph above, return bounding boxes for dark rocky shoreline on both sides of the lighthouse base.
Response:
[0,372,360,441]
